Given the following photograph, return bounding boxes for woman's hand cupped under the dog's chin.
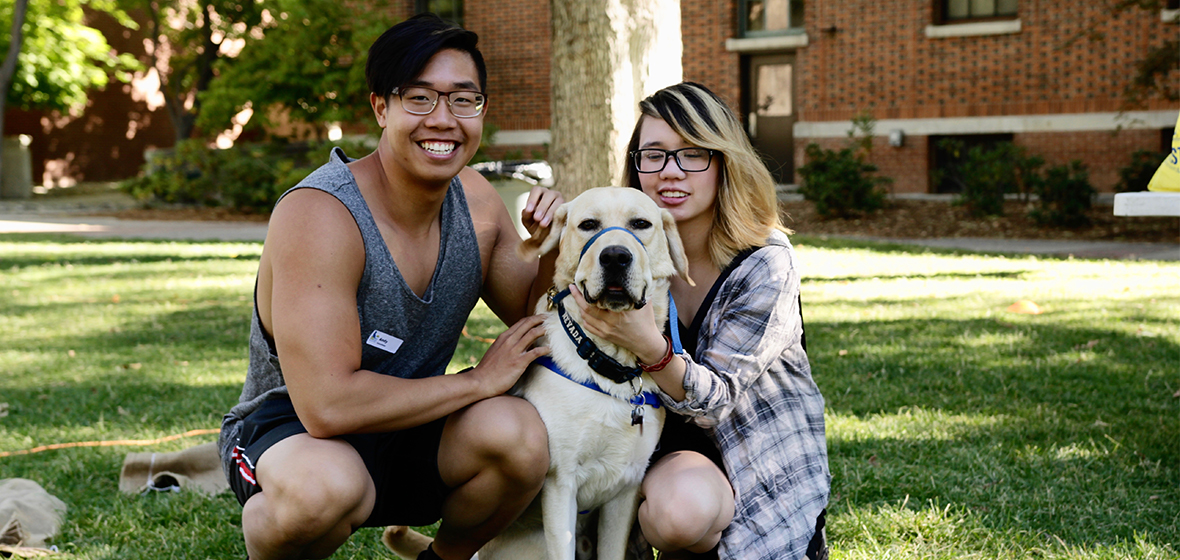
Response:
[570,284,668,363]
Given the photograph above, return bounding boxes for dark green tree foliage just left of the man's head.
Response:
[198,0,393,137]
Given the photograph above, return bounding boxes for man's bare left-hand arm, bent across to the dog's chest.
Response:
[260,190,544,437]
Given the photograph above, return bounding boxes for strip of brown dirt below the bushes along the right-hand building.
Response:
[782,199,1180,243]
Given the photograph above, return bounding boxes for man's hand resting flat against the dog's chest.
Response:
[468,315,549,396]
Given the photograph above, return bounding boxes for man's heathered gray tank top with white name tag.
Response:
[218,147,483,457]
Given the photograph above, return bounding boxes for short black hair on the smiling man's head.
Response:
[365,13,487,98]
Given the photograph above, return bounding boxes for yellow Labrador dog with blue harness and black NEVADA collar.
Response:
[488,187,688,560]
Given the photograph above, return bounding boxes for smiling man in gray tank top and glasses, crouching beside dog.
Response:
[219,15,562,560]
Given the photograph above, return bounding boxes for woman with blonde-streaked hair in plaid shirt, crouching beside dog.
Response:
[571,83,831,560]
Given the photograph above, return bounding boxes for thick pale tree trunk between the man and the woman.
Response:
[549,0,681,199]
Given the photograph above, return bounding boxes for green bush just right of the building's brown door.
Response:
[799,144,890,218]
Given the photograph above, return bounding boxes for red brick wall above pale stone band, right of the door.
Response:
[797,0,1180,121]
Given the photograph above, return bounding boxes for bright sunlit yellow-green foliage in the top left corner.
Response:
[0,0,138,112]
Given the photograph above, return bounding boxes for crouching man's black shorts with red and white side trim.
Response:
[228,396,451,527]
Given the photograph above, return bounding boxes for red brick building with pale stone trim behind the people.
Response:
[8,0,1180,192]
